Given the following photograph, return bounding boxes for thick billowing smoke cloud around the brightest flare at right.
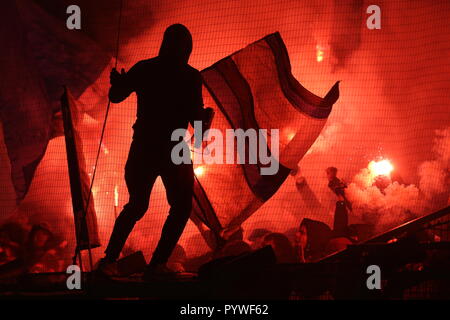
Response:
[347,127,450,231]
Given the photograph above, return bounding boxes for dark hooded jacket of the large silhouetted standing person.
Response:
[109,24,203,146]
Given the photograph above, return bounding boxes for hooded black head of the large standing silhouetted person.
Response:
[159,24,192,63]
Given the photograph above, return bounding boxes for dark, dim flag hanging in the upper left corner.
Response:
[0,0,110,203]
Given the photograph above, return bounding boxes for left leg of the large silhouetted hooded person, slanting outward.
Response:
[105,142,158,261]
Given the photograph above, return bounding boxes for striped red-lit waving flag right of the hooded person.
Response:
[192,33,339,239]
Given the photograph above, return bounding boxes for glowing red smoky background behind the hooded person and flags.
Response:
[0,0,450,268]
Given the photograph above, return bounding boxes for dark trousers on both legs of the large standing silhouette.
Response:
[105,140,194,265]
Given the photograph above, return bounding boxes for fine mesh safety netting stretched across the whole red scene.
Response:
[0,0,450,272]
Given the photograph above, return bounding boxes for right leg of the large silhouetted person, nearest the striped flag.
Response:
[149,164,194,267]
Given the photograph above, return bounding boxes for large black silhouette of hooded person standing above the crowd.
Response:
[99,24,209,275]
